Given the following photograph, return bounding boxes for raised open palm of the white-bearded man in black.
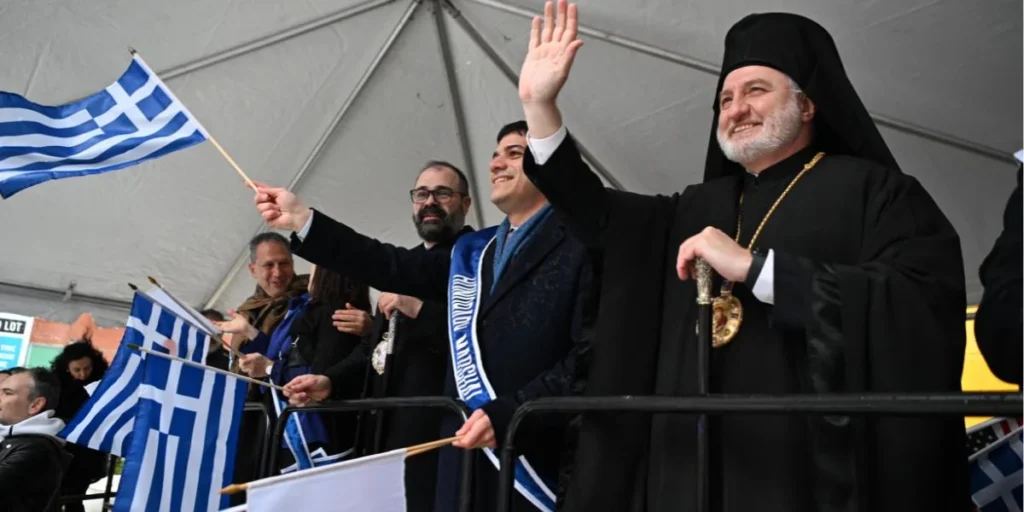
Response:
[519,0,583,105]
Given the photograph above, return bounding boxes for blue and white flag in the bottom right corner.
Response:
[969,428,1024,512]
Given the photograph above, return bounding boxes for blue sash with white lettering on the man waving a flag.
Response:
[449,226,555,512]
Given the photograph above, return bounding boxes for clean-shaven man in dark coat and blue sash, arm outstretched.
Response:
[264,122,592,512]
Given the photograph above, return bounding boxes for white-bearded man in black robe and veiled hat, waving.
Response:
[519,0,970,512]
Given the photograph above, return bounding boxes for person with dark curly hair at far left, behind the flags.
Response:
[50,340,109,512]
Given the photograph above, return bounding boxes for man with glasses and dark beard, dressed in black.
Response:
[264,160,473,512]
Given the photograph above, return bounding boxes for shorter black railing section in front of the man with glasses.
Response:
[270,396,474,512]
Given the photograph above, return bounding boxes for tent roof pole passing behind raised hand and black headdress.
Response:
[467,0,1016,166]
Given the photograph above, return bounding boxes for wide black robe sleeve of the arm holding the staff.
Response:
[774,173,967,392]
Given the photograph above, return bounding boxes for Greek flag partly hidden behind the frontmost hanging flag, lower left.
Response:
[58,293,209,457]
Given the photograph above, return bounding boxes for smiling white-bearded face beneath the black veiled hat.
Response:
[718,66,814,172]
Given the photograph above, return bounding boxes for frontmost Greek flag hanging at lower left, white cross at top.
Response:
[114,313,248,512]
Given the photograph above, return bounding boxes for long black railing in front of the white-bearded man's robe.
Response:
[496,393,1024,512]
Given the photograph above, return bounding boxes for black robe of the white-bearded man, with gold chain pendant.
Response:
[524,136,970,512]
